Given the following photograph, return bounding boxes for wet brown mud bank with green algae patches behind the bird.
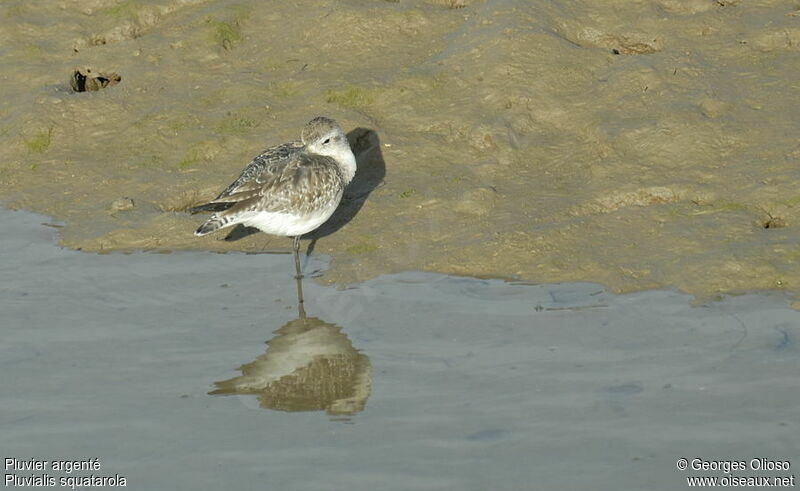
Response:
[0,0,800,304]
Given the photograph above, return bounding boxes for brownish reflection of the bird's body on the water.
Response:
[209,304,372,415]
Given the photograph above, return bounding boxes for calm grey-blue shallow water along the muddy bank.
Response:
[0,211,800,491]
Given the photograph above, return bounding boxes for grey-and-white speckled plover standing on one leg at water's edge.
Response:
[190,117,356,310]
